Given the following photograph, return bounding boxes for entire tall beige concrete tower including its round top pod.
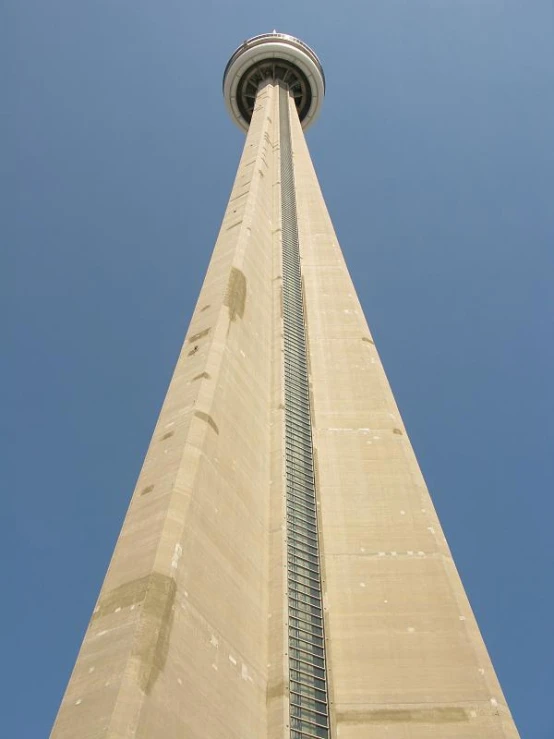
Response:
[52,33,518,739]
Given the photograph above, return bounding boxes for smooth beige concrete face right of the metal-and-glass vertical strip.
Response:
[291,89,519,739]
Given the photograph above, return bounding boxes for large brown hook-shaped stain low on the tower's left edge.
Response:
[92,572,177,694]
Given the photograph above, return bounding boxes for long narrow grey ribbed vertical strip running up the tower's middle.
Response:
[279,83,330,739]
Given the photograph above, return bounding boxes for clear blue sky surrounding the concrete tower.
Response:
[5,0,554,739]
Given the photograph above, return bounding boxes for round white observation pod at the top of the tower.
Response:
[223,31,325,131]
